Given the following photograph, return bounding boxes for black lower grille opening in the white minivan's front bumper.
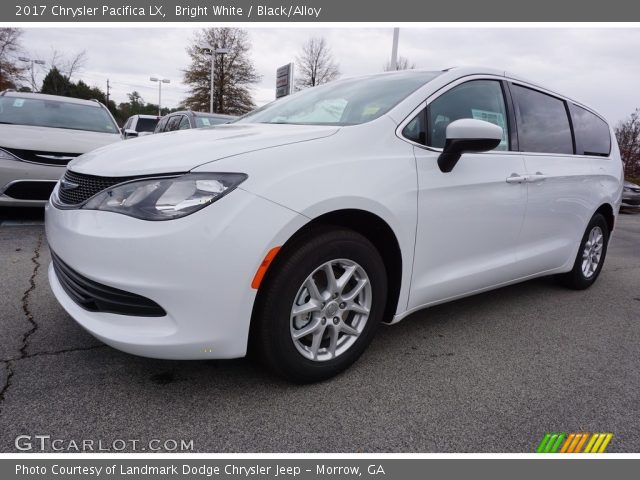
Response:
[51,252,167,317]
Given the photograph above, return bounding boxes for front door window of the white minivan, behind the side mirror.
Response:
[427,80,509,150]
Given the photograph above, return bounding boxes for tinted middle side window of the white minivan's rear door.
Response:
[511,85,573,154]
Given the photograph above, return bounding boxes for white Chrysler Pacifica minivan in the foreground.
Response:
[46,68,623,382]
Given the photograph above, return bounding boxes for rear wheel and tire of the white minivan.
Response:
[559,213,609,290]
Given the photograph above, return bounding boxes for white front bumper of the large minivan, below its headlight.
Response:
[46,189,307,359]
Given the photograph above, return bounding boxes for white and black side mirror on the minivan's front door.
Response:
[438,118,502,173]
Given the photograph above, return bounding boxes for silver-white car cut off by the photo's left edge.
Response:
[0,90,120,207]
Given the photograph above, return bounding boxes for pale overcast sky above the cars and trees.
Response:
[17,26,640,123]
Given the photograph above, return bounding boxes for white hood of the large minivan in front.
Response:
[69,124,339,177]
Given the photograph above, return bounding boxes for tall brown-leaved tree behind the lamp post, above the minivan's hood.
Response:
[184,27,260,115]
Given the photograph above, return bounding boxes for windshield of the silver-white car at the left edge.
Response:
[0,97,118,133]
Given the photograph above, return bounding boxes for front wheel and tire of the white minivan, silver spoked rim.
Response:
[252,227,387,383]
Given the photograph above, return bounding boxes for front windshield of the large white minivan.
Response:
[237,70,441,125]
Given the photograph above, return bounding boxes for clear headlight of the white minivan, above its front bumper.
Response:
[81,173,247,220]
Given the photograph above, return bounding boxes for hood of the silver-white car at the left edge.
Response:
[0,125,120,153]
